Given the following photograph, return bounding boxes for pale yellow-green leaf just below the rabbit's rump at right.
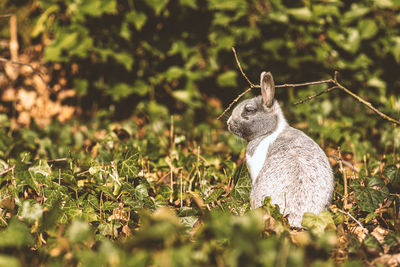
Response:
[301,211,335,237]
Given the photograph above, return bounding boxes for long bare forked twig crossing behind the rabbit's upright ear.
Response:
[217,47,400,125]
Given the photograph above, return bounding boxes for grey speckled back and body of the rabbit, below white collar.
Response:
[250,126,333,227]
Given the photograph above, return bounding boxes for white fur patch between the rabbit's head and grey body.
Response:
[246,117,286,184]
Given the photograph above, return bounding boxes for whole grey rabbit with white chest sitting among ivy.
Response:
[227,72,334,227]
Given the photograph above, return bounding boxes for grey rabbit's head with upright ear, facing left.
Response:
[227,72,284,141]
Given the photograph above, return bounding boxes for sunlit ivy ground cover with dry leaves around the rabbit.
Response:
[0,114,400,267]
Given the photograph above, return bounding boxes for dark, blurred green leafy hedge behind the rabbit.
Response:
[1,0,400,157]
